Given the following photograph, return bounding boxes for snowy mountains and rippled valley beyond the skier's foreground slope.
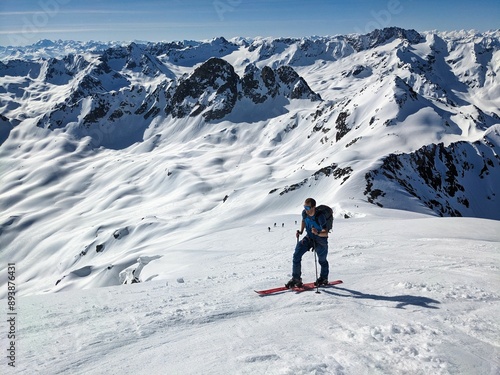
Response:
[0,28,500,300]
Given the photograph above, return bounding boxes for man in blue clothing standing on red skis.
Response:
[285,198,329,288]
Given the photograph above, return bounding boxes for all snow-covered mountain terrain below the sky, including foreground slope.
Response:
[0,27,500,374]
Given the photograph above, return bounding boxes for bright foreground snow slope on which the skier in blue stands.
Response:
[2,218,500,375]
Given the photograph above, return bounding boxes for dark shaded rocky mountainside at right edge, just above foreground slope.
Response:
[365,139,500,218]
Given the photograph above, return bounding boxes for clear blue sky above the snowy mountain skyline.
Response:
[0,0,500,46]
